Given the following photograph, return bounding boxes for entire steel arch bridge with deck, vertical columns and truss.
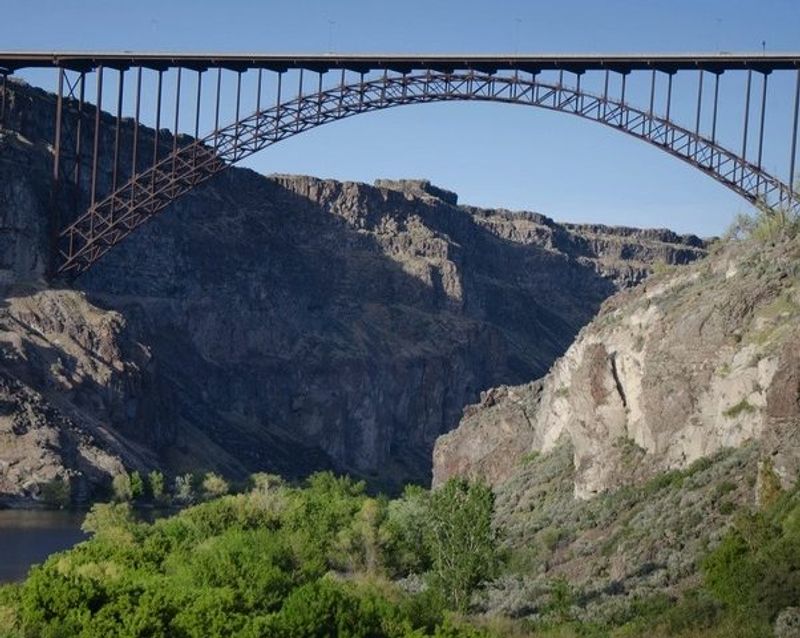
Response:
[0,52,800,277]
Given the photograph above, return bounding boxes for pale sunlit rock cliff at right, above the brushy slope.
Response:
[433,235,800,498]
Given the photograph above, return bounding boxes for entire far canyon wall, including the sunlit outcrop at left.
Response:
[0,79,705,500]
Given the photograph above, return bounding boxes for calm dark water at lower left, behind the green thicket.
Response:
[0,510,86,583]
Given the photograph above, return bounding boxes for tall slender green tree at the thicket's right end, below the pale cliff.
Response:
[427,479,500,612]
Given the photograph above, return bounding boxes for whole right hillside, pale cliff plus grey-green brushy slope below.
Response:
[434,224,800,624]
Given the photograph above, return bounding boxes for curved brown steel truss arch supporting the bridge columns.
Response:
[59,70,800,275]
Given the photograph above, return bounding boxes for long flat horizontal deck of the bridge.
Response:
[0,51,800,73]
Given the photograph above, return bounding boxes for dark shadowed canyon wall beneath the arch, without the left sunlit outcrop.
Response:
[76,171,702,488]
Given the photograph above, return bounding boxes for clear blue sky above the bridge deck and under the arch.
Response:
[0,0,800,235]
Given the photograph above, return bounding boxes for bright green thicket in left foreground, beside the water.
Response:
[0,473,497,638]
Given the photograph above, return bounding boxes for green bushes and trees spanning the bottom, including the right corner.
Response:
[6,460,800,638]
